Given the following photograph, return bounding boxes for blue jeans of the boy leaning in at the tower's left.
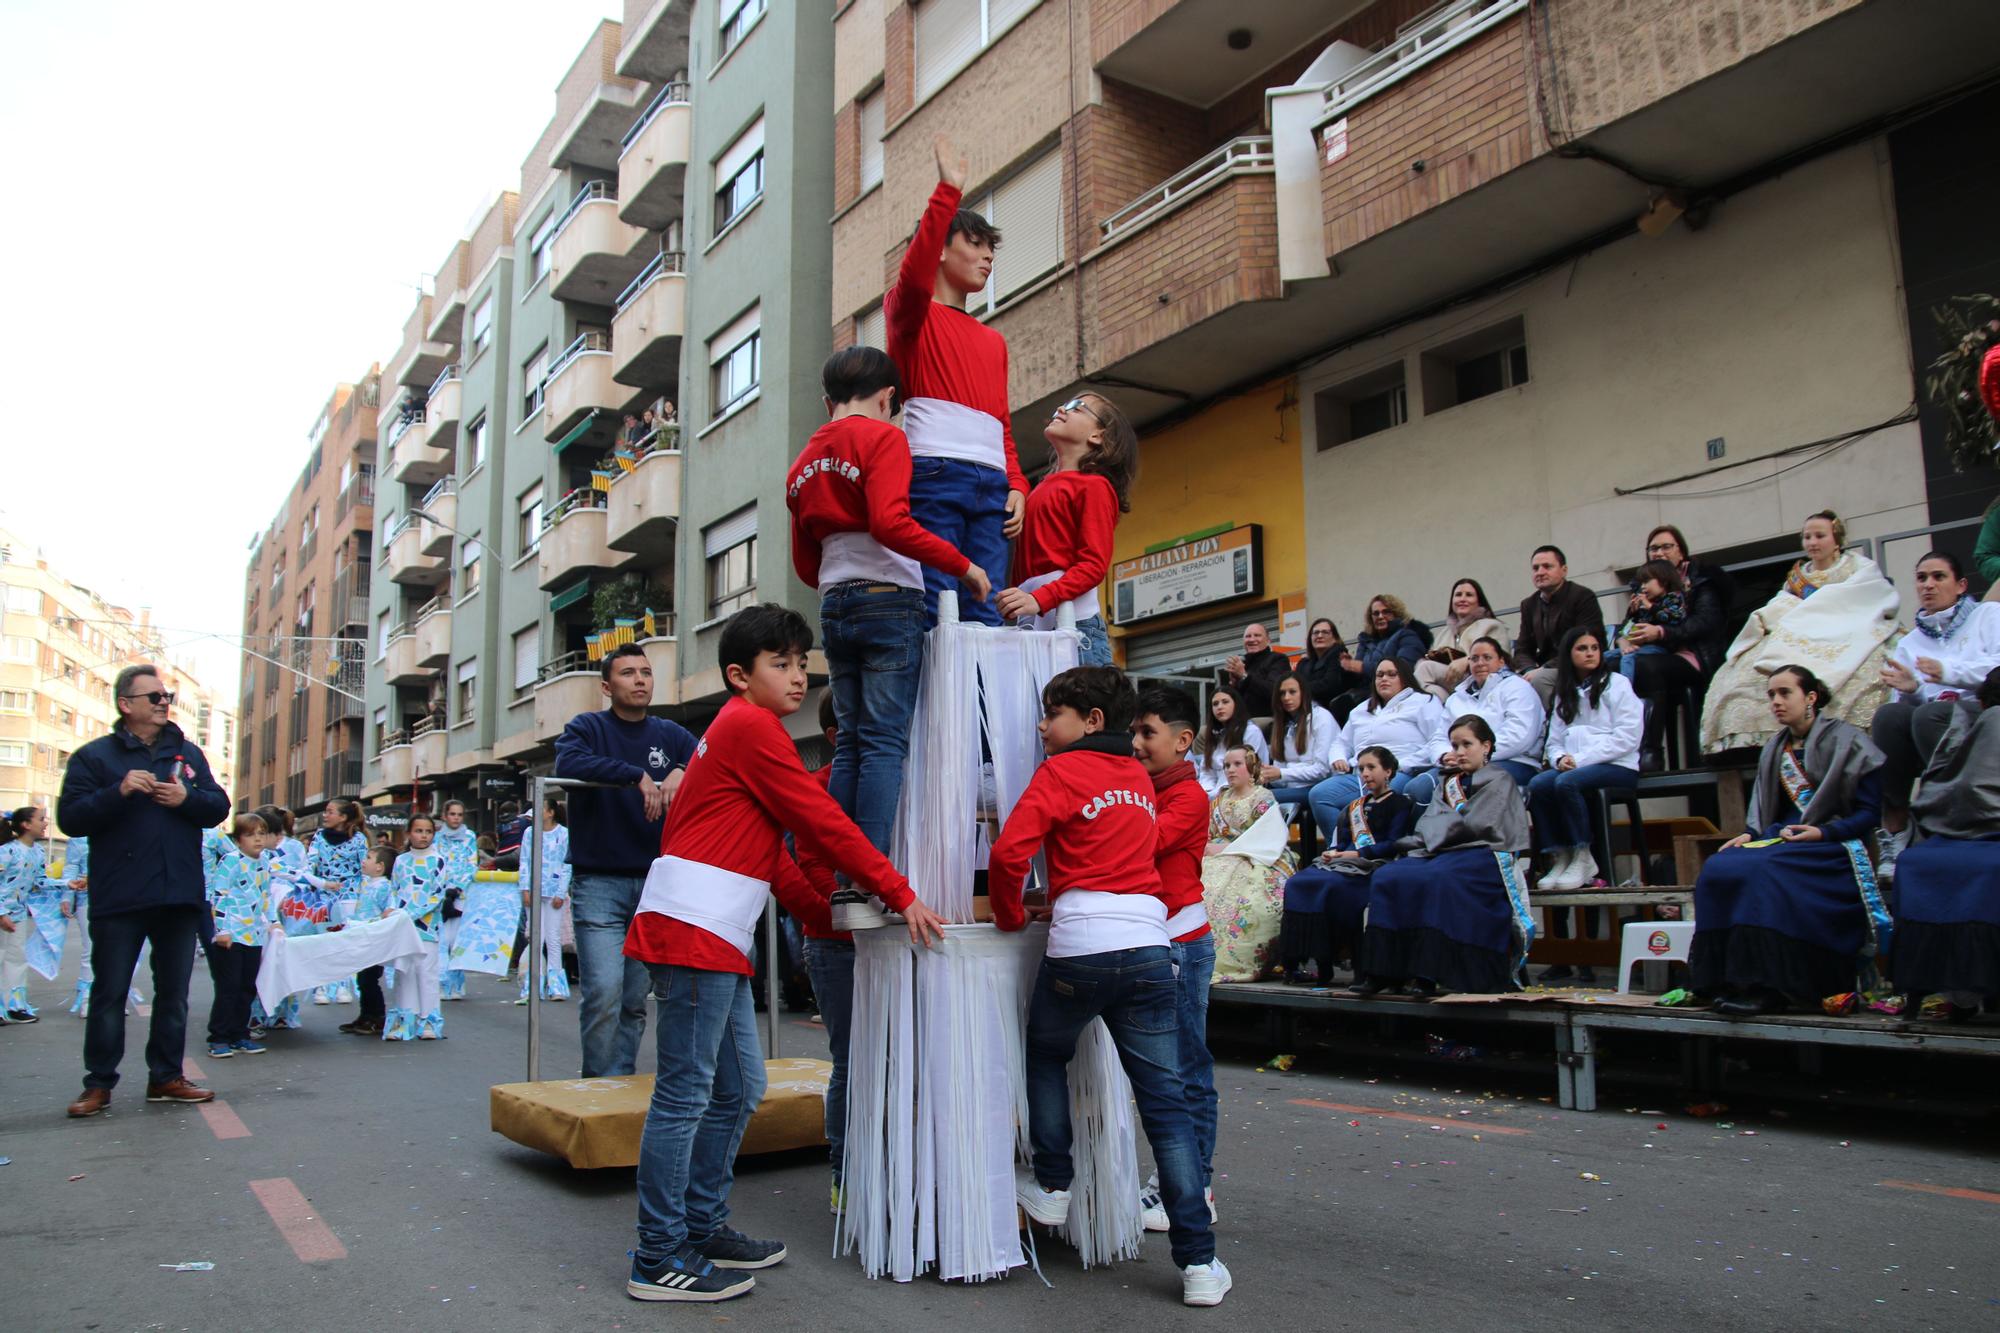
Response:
[638,963,764,1263]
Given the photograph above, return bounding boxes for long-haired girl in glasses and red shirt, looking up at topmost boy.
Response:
[994,392,1138,667]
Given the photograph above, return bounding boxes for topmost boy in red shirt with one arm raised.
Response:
[882,134,1028,624]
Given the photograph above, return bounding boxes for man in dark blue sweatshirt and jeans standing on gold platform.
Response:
[556,642,694,1079]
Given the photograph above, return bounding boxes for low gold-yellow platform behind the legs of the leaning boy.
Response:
[490,1059,834,1171]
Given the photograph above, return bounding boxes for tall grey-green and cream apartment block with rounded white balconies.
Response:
[362,0,832,807]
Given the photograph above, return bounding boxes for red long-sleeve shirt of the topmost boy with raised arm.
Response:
[882,180,1028,494]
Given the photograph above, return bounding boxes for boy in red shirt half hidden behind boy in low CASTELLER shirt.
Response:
[1132,685,1216,1231]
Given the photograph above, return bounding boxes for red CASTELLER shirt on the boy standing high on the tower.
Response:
[784,416,972,588]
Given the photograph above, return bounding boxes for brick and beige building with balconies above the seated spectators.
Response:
[832,0,2000,673]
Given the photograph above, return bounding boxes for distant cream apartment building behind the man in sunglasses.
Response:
[0,530,238,845]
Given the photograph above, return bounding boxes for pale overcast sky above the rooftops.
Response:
[0,0,620,699]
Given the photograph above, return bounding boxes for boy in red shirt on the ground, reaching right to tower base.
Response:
[626,602,942,1301]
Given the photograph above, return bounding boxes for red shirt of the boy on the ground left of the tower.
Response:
[624,695,914,975]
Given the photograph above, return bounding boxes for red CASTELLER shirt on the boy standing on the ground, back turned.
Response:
[986,737,1166,957]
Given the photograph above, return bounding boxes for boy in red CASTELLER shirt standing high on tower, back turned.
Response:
[784,346,990,872]
